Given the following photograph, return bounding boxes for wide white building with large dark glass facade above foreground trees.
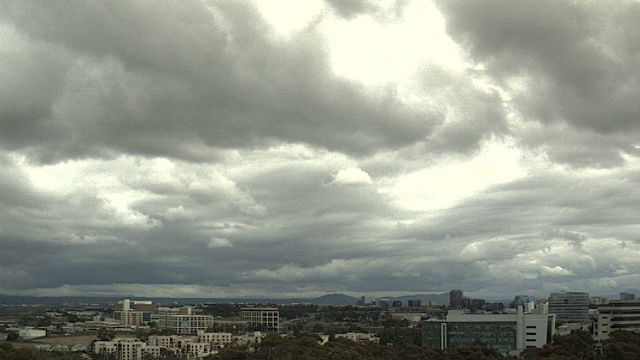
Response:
[422,307,555,354]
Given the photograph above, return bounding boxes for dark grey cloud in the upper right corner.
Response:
[440,0,640,167]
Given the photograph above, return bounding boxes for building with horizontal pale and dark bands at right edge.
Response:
[593,300,640,341]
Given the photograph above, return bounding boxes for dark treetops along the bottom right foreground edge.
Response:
[209,331,640,360]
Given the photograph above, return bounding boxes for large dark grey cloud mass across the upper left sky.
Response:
[0,1,441,160]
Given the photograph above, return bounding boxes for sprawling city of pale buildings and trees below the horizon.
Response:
[0,290,640,360]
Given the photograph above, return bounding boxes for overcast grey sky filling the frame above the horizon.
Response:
[0,0,640,298]
